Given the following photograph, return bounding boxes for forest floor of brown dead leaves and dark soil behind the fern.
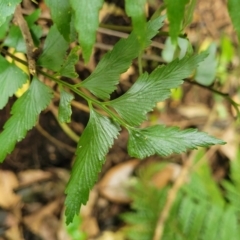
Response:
[0,0,240,240]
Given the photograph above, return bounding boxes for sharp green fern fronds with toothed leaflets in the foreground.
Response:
[0,0,238,224]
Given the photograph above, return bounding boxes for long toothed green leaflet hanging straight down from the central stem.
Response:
[65,110,120,223]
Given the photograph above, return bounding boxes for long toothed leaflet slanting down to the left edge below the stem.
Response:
[0,78,52,162]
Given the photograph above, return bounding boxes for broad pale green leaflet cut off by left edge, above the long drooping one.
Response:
[0,56,28,109]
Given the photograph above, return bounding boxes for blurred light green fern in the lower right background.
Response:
[122,150,240,240]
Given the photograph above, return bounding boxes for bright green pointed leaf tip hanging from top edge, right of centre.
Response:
[165,0,189,42]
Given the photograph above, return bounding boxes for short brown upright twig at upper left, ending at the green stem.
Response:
[14,5,37,75]
